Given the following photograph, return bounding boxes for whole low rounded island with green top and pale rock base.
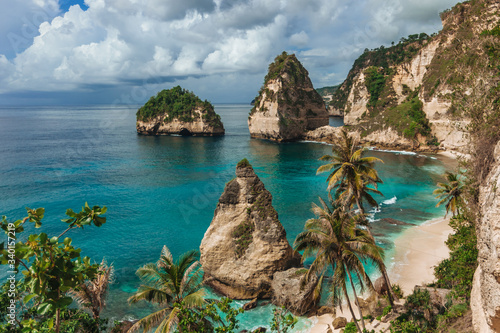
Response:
[137,86,225,136]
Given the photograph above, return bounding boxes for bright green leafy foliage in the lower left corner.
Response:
[0,203,106,333]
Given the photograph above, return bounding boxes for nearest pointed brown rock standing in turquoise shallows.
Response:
[200,160,300,299]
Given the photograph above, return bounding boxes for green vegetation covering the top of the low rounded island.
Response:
[136,86,222,127]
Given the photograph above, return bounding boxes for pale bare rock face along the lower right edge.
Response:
[471,143,500,333]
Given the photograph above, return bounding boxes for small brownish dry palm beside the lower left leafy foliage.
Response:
[69,260,115,322]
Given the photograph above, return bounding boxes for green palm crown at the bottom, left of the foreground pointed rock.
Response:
[128,246,205,333]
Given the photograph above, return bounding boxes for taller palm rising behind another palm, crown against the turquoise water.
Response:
[317,128,396,306]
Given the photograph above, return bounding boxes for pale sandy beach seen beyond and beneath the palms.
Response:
[311,218,452,333]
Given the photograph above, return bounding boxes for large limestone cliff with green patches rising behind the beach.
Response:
[330,0,500,150]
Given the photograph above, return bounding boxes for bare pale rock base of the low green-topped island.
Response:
[137,108,225,136]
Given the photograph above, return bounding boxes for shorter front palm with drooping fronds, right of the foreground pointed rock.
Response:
[294,199,383,332]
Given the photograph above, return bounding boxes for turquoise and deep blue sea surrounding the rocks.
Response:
[0,105,453,330]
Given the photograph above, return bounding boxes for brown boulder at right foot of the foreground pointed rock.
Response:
[271,268,318,316]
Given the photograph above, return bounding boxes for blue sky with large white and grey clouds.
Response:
[0,0,457,105]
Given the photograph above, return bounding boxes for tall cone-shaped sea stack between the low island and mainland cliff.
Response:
[248,52,329,142]
